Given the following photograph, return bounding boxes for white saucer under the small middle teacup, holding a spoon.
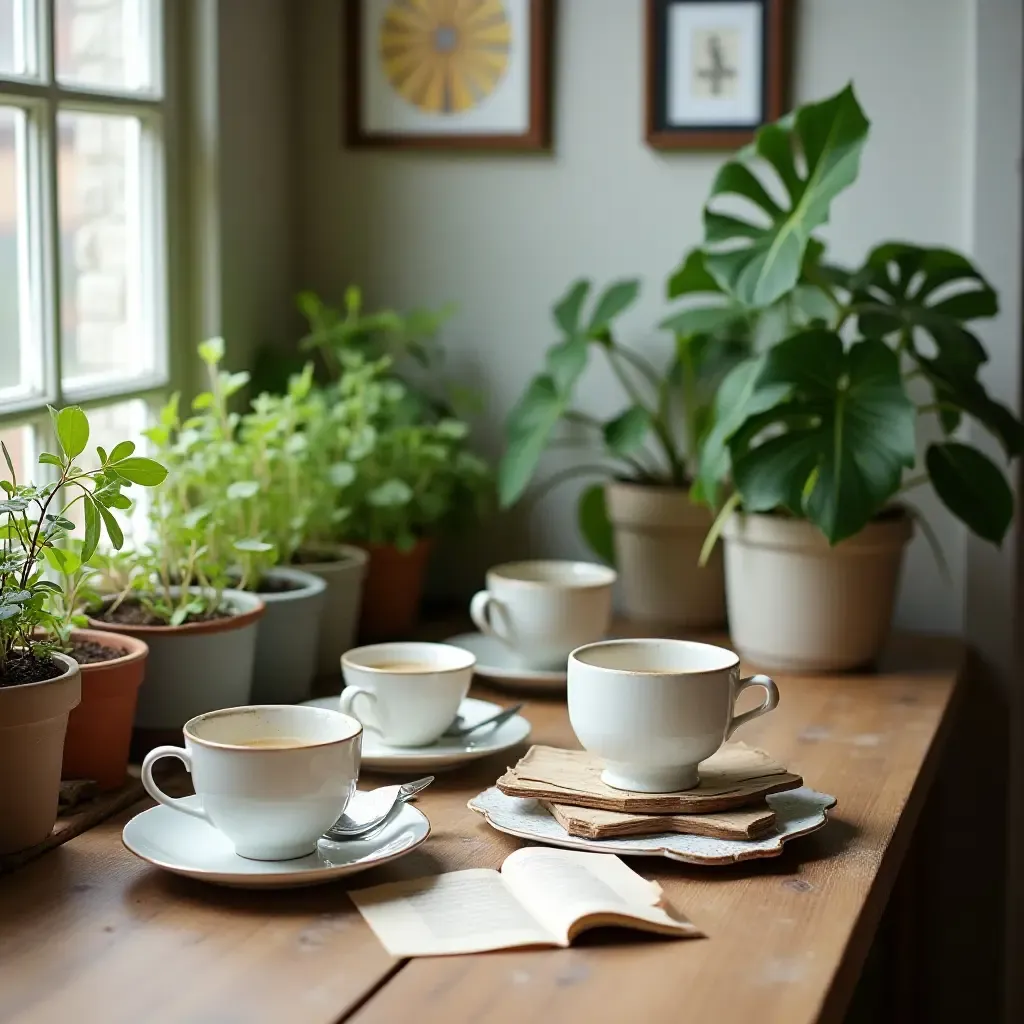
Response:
[304,697,529,774]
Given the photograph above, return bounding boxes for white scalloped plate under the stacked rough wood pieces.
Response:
[468,785,836,864]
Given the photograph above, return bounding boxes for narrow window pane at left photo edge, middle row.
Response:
[0,106,42,410]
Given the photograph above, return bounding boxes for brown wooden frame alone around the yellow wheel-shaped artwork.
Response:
[342,0,555,151]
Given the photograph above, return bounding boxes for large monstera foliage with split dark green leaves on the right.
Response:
[699,87,1024,555]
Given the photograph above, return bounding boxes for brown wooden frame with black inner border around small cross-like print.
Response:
[646,0,793,150]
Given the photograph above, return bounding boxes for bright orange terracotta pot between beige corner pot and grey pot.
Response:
[60,630,150,791]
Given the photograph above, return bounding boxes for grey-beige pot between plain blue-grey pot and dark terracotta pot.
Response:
[301,544,369,676]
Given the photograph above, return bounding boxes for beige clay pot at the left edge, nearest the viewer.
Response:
[0,654,82,854]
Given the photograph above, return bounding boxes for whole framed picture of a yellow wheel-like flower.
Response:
[343,0,554,150]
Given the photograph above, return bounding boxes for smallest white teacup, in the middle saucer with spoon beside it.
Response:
[341,642,476,746]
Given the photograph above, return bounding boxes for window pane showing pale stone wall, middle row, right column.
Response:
[57,112,158,388]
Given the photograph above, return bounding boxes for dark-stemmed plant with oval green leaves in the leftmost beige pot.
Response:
[0,406,167,681]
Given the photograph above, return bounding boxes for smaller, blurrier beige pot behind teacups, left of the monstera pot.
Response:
[604,480,725,630]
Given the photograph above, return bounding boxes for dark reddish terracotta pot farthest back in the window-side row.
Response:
[359,538,433,641]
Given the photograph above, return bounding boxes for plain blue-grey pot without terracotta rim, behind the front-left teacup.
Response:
[251,568,327,703]
